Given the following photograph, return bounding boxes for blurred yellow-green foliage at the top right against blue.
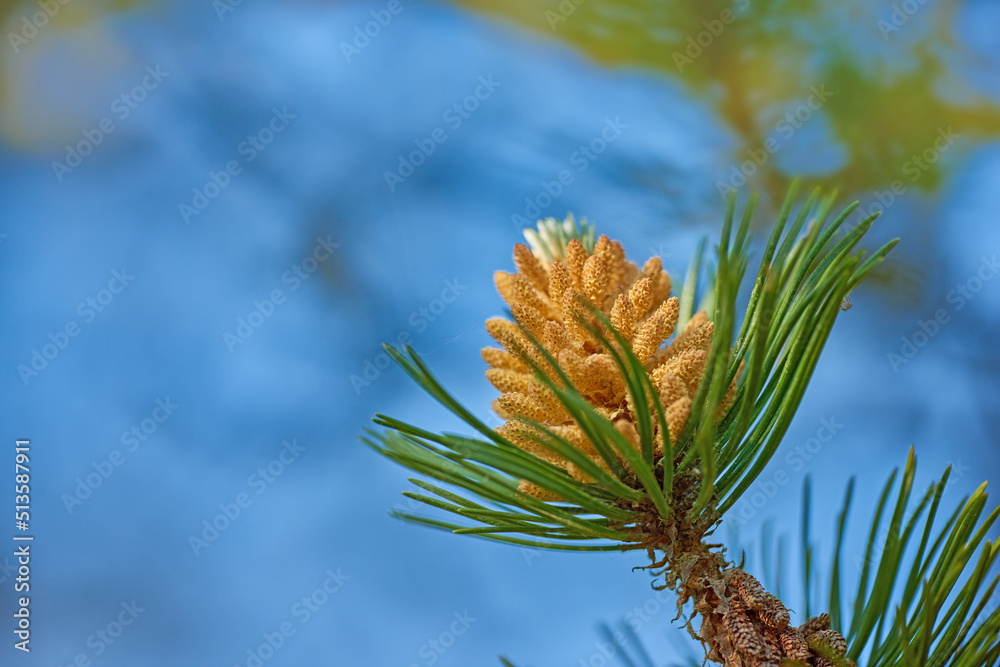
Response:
[457,0,1000,200]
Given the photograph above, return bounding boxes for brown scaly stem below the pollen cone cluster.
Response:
[618,472,856,667]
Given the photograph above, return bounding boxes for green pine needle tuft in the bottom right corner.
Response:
[816,449,1000,667]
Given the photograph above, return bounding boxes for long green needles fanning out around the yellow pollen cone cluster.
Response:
[372,187,904,548]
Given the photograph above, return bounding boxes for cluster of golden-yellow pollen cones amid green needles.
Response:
[483,236,736,501]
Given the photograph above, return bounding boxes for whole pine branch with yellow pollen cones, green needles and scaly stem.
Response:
[363,187,1000,667]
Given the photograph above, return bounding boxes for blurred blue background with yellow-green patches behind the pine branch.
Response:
[0,0,1000,667]
